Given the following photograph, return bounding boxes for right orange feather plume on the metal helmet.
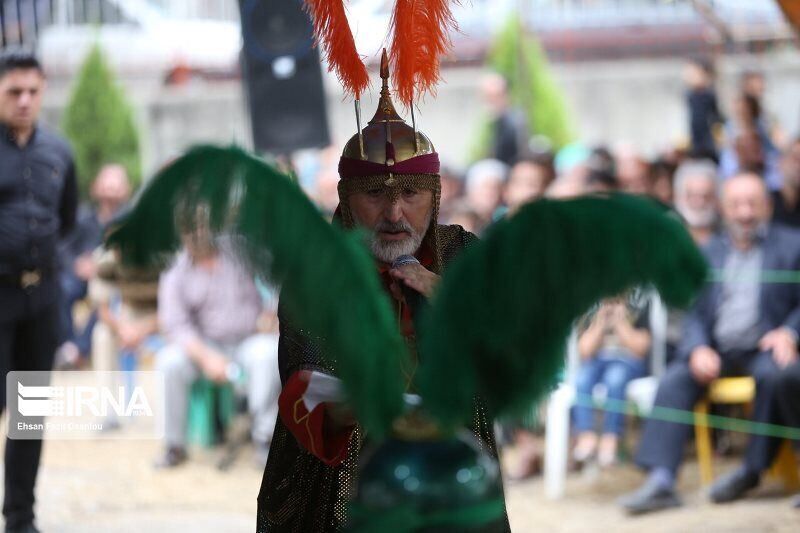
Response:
[389,0,457,105]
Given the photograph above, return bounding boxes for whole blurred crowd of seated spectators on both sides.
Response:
[59,67,800,513]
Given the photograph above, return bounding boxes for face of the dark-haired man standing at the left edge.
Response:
[0,69,44,130]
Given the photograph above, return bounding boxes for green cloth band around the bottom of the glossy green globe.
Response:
[347,498,505,533]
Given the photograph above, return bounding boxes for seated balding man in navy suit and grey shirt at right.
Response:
[620,173,800,514]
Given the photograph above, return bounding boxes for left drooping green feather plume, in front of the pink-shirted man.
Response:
[108,146,408,436]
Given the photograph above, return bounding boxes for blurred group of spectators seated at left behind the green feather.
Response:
[57,165,281,467]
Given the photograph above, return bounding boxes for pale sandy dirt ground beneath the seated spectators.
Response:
[0,434,800,533]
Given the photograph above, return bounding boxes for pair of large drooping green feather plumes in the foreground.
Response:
[109,147,706,437]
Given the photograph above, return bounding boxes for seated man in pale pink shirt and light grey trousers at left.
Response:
[156,224,281,467]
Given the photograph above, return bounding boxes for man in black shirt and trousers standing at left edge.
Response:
[0,52,77,533]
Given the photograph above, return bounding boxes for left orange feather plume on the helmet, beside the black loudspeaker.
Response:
[305,0,369,98]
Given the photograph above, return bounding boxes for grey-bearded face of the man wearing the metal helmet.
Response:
[349,187,433,263]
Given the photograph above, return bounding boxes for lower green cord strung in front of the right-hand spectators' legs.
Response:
[575,394,800,440]
